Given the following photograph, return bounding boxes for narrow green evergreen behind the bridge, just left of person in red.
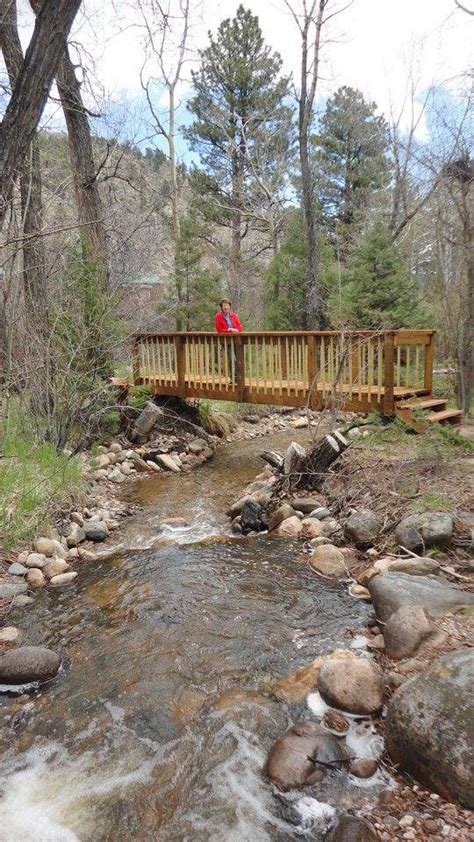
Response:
[175,214,220,330]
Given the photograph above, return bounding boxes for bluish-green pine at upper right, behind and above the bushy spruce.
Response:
[315,87,390,262]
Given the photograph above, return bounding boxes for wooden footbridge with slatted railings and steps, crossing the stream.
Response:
[132,330,461,424]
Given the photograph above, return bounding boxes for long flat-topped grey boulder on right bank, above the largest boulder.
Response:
[368,572,474,623]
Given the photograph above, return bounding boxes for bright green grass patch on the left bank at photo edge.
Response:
[0,406,83,549]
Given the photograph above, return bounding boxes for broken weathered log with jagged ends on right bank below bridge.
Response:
[261,430,349,489]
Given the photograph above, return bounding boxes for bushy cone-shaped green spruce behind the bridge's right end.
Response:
[333,223,424,328]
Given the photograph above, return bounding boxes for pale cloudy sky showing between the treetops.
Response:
[7,0,474,157]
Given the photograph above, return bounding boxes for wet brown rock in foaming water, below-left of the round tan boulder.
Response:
[264,722,348,791]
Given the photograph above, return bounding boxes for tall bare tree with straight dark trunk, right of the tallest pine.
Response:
[284,0,350,328]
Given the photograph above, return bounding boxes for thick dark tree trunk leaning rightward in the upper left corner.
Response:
[0,0,81,228]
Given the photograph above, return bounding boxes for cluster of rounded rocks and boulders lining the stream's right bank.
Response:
[228,434,474,820]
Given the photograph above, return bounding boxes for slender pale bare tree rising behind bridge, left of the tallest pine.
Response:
[138,0,190,330]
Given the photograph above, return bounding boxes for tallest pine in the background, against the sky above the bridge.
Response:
[186,5,291,306]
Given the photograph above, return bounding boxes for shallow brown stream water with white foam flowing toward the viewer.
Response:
[0,435,386,842]
